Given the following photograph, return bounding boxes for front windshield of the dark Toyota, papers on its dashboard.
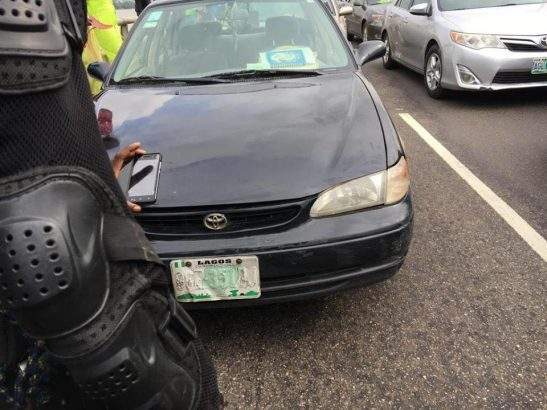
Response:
[113,0,351,84]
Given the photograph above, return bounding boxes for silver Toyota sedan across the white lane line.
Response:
[382,0,547,98]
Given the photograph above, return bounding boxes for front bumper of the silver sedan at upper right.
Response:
[443,44,547,91]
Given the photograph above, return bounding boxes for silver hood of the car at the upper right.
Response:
[442,3,547,35]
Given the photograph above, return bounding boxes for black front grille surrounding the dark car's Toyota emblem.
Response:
[136,198,313,239]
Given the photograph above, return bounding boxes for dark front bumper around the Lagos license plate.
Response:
[153,196,412,308]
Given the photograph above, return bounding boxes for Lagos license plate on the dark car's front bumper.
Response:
[171,256,260,302]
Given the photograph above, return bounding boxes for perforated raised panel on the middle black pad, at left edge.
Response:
[0,219,74,309]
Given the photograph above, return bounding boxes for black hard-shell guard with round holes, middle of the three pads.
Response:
[0,168,110,339]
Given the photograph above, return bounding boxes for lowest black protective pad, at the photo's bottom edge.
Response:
[65,298,202,410]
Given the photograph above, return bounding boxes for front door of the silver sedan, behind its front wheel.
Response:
[401,0,433,70]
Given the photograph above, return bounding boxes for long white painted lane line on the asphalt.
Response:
[399,113,547,262]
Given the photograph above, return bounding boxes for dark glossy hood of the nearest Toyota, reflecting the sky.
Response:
[96,72,386,207]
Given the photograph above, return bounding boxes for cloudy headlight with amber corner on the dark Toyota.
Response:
[310,157,410,218]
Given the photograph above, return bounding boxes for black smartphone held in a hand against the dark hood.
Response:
[127,154,161,204]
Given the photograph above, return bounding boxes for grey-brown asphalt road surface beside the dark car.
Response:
[193,62,547,408]
